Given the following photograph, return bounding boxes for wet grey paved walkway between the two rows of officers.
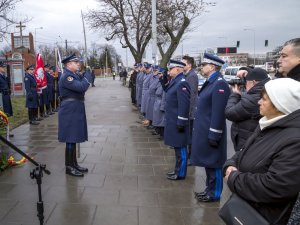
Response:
[0,78,232,225]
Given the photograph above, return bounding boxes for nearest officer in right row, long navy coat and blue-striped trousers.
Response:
[191,53,230,202]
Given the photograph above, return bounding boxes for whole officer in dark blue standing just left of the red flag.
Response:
[24,65,39,125]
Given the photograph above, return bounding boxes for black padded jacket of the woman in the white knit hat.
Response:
[223,110,300,225]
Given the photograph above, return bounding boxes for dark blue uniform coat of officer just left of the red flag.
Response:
[24,73,39,108]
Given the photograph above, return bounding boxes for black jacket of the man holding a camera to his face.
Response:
[225,78,270,151]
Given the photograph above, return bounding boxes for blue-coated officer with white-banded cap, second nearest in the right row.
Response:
[163,60,190,180]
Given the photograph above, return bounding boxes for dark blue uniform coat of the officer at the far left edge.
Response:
[0,73,13,116]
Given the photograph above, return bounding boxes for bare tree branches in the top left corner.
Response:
[0,0,22,38]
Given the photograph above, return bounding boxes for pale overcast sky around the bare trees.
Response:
[4,0,300,64]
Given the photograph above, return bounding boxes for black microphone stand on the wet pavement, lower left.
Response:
[0,135,51,225]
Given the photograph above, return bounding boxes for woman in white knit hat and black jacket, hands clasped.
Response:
[223,78,300,225]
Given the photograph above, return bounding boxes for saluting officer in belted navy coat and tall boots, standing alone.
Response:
[58,54,92,177]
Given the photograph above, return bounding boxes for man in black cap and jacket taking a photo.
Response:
[225,68,270,151]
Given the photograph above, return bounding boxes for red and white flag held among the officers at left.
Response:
[34,53,47,93]
